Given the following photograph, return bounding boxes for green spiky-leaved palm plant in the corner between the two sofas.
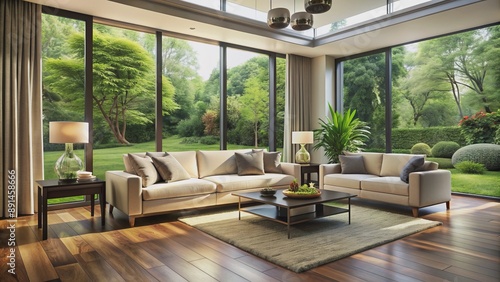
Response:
[313,104,370,163]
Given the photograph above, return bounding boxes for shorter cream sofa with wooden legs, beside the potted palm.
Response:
[319,152,451,217]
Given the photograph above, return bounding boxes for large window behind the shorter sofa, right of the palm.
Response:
[337,25,500,197]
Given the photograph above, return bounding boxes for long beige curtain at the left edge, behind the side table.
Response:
[0,0,43,217]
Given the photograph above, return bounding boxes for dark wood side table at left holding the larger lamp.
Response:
[36,179,106,240]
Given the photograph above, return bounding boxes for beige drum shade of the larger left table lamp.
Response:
[49,121,89,143]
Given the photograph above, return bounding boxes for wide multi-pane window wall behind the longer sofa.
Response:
[43,8,285,207]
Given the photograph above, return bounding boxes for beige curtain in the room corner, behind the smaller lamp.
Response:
[283,55,312,162]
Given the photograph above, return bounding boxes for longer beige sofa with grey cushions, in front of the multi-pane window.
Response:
[106,150,300,226]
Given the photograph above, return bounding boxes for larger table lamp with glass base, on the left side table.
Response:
[49,121,89,182]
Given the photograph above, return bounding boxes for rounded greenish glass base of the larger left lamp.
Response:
[54,143,83,183]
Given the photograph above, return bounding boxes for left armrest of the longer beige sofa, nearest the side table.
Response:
[106,170,142,216]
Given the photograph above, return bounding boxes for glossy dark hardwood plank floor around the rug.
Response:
[0,195,500,282]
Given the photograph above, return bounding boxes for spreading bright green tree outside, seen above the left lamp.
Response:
[46,31,177,144]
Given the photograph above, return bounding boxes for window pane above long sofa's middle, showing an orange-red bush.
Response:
[161,36,220,151]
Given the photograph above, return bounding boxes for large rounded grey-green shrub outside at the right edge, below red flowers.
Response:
[451,144,500,170]
